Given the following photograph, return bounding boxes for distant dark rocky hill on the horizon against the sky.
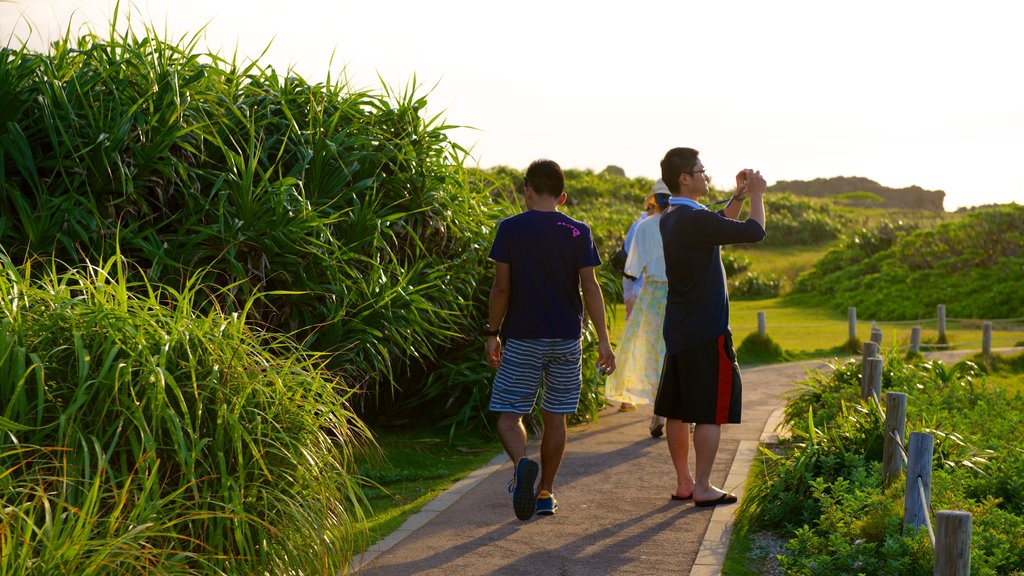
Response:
[768,176,946,212]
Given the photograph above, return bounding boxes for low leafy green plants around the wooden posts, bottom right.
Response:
[737,356,1024,574]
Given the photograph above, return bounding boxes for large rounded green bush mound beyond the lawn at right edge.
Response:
[790,204,1024,320]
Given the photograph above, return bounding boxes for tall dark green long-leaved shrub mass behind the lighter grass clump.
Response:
[0,10,511,411]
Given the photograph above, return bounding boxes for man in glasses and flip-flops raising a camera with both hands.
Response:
[654,148,765,506]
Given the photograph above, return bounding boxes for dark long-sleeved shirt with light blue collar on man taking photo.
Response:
[659,201,765,355]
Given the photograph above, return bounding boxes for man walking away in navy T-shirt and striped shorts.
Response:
[484,160,615,520]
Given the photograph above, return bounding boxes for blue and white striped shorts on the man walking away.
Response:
[489,338,583,414]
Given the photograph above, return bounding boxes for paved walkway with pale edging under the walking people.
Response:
[352,353,1015,576]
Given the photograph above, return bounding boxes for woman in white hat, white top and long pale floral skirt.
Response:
[604,179,670,438]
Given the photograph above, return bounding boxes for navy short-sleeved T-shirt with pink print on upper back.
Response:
[489,210,601,339]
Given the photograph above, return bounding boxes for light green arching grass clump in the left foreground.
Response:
[0,256,372,575]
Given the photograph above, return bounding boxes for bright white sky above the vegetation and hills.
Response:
[0,0,1024,210]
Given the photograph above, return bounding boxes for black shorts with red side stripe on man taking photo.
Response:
[654,334,742,424]
